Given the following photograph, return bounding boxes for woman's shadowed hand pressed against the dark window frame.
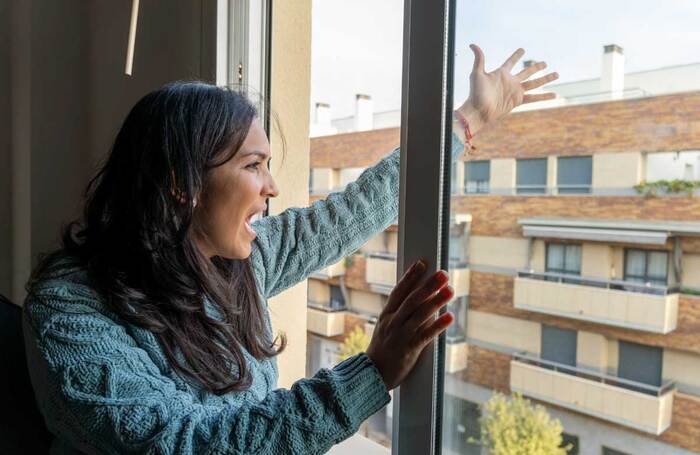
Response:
[367,261,454,390]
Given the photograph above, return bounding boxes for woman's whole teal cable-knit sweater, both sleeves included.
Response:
[24,138,462,454]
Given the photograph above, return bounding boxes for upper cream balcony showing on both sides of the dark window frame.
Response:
[365,253,469,297]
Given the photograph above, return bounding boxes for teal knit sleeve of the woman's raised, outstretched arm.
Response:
[251,134,464,298]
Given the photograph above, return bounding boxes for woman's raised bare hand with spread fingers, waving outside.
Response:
[458,44,559,134]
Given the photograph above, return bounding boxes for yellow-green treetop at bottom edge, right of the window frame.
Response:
[479,393,571,455]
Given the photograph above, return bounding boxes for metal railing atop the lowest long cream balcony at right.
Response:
[513,352,676,397]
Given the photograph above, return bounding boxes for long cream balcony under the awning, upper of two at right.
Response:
[513,272,678,333]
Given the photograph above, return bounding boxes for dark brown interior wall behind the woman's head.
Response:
[5,0,216,303]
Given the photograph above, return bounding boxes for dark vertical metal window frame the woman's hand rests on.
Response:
[391,0,456,455]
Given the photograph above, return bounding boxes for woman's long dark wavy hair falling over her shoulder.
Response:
[28,82,286,395]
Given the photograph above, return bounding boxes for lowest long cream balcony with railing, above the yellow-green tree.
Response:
[510,354,675,435]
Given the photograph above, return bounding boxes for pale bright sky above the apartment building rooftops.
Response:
[311,0,700,118]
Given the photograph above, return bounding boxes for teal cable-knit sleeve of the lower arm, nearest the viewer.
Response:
[24,288,389,454]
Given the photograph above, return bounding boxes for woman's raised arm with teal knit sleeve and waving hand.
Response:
[251,45,557,297]
